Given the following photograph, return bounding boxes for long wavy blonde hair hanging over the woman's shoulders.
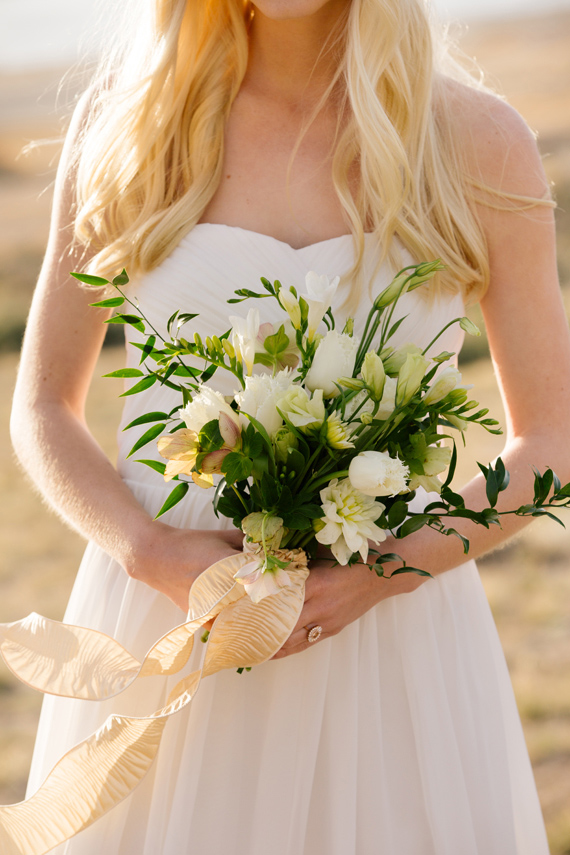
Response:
[71,0,536,300]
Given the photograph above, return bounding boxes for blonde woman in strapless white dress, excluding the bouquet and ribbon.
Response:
[5,0,570,855]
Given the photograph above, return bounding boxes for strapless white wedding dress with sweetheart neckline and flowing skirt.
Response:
[24,224,548,855]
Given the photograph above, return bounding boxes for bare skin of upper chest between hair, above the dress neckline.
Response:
[197,86,350,248]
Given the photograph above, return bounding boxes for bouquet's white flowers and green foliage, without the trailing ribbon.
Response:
[73,260,570,602]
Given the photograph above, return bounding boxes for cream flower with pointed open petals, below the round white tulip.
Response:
[315,478,386,564]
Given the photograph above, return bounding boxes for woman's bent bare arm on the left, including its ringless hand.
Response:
[11,101,239,610]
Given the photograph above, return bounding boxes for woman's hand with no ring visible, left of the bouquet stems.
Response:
[125,522,243,612]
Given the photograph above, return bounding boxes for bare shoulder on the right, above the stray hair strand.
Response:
[435,77,549,198]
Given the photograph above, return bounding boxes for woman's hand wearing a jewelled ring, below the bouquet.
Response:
[273,560,426,659]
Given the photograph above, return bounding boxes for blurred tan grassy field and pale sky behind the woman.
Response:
[0,0,570,855]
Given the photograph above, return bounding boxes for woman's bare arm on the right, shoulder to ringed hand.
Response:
[277,86,570,657]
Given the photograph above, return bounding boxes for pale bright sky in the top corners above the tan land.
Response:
[0,0,570,72]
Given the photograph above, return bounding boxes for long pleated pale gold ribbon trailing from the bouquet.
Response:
[0,549,309,855]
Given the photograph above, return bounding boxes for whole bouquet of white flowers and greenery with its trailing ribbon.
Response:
[0,261,570,855]
